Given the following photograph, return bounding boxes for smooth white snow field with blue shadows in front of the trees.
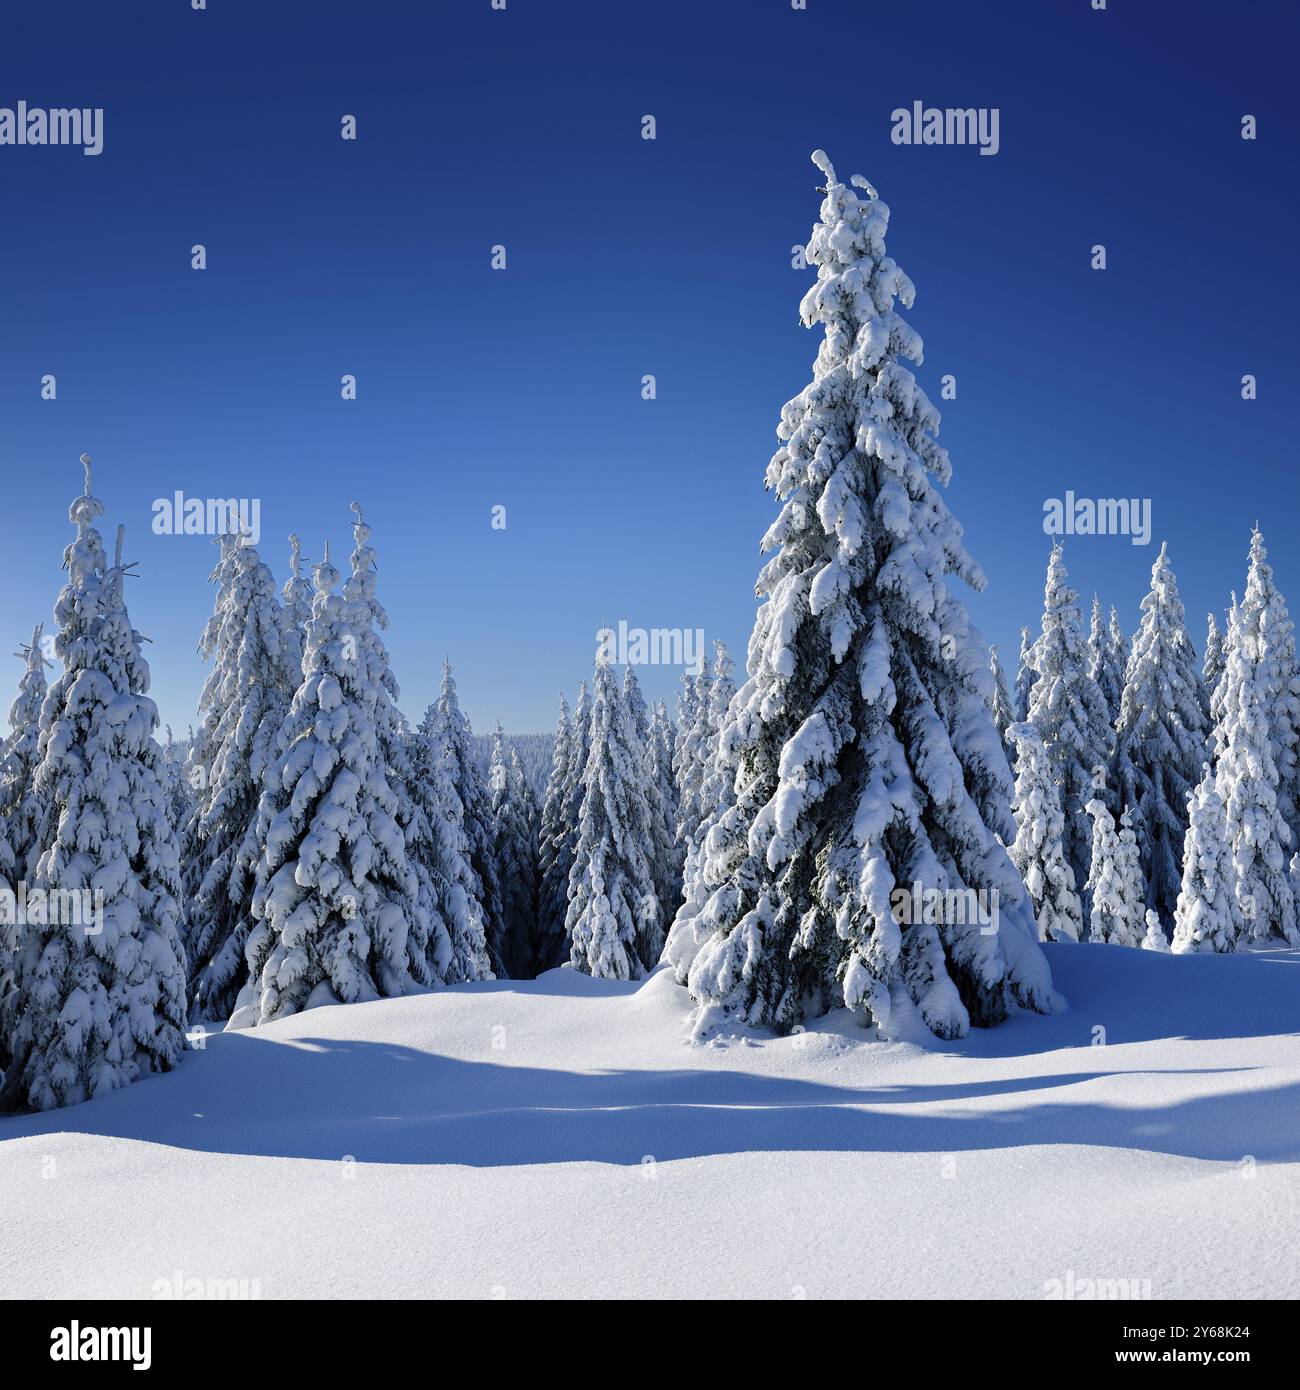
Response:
[0,945,1300,1298]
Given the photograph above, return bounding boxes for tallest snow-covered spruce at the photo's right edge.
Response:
[1211,531,1300,945]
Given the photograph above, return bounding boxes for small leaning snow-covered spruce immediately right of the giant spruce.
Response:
[1009,720,1083,941]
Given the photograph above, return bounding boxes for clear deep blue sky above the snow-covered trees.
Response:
[0,0,1300,731]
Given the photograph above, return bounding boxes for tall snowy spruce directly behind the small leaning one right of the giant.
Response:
[1029,545,1114,883]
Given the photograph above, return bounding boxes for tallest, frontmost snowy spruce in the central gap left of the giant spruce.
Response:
[564,656,663,980]
